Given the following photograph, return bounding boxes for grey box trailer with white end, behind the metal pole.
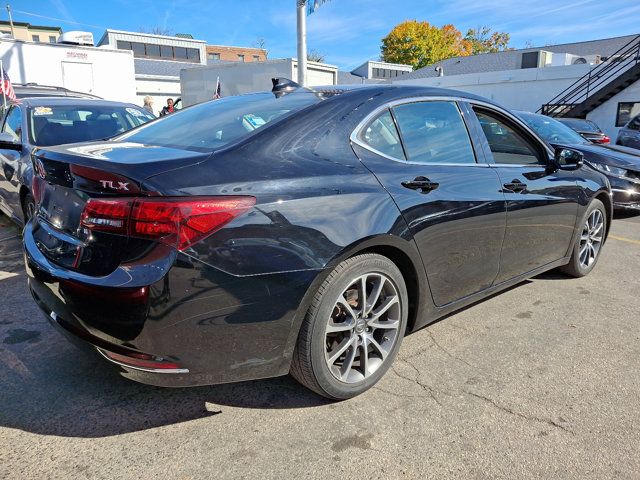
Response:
[180,58,338,106]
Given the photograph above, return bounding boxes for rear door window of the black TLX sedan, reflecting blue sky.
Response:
[393,101,476,164]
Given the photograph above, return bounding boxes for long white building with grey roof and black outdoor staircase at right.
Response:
[393,35,640,139]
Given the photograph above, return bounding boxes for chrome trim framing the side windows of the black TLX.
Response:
[349,95,554,168]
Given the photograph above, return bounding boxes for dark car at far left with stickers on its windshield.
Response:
[0,97,155,223]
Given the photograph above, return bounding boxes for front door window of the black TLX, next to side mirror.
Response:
[474,108,546,165]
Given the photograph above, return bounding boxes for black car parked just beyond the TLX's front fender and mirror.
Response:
[517,112,640,210]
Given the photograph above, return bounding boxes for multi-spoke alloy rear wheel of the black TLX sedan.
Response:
[325,273,402,383]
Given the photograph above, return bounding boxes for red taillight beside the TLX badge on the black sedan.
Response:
[80,196,256,250]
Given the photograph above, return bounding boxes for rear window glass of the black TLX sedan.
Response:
[118,93,321,151]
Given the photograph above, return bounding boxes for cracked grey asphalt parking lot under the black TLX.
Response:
[0,215,640,479]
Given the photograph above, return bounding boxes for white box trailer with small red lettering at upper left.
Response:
[0,39,137,103]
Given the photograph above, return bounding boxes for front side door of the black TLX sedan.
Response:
[468,102,581,283]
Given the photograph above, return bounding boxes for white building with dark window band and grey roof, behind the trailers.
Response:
[98,29,207,113]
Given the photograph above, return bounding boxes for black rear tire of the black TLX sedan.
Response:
[291,254,409,400]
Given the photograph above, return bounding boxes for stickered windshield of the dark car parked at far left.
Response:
[28,103,155,147]
